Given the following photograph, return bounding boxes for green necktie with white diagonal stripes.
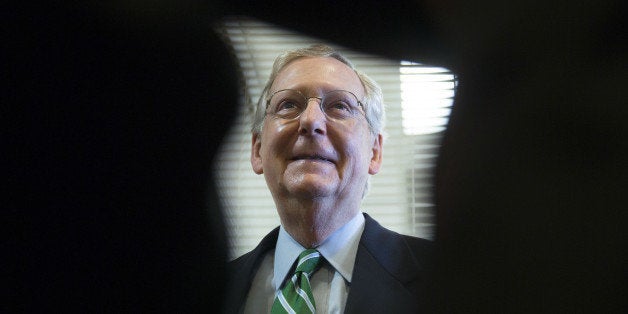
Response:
[270,249,321,314]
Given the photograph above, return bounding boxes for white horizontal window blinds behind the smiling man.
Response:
[214,18,454,258]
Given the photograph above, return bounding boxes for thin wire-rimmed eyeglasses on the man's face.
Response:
[266,89,365,120]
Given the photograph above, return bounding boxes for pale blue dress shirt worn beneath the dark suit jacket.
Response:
[244,212,364,313]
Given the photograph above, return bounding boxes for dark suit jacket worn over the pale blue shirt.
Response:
[225,214,432,313]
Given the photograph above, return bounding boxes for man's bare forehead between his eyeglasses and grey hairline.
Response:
[271,57,364,98]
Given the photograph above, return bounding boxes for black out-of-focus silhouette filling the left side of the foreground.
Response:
[8,1,238,313]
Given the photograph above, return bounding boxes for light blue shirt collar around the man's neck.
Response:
[272,212,364,290]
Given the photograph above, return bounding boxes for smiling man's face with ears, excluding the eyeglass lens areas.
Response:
[251,57,382,206]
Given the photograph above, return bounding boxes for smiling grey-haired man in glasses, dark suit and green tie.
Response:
[226,45,431,313]
